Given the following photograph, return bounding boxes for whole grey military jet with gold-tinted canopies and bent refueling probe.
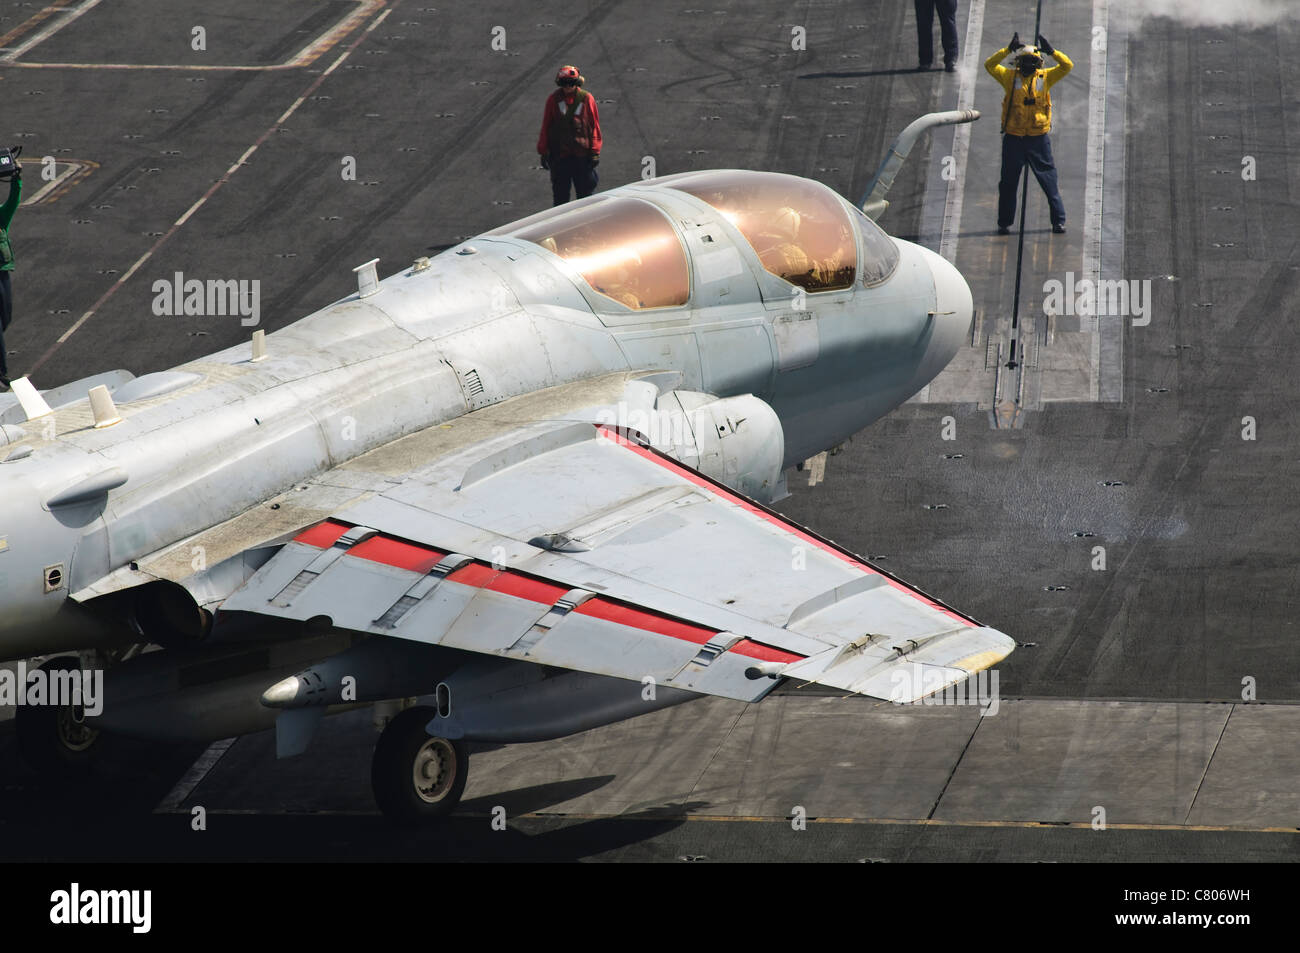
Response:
[0,113,1014,823]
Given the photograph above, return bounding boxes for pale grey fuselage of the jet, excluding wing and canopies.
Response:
[0,171,971,659]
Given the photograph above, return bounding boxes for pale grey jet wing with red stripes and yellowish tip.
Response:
[221,382,1015,701]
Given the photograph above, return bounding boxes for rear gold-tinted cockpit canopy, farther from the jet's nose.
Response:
[489,198,690,311]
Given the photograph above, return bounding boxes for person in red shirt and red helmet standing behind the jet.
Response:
[537,66,601,205]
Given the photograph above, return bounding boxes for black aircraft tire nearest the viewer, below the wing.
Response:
[371,706,469,827]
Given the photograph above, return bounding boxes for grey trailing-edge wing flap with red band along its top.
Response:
[222,521,780,701]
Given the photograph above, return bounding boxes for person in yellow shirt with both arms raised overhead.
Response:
[984,33,1074,235]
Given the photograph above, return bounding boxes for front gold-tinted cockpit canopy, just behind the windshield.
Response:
[664,170,858,291]
